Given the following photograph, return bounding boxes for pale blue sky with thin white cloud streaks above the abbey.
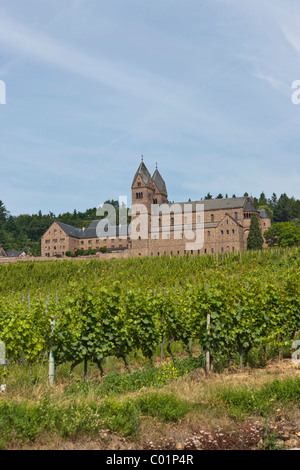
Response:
[0,0,300,215]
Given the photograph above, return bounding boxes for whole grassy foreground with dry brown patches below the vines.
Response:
[0,357,300,449]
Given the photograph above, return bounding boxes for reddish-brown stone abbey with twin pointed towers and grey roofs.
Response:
[41,159,271,258]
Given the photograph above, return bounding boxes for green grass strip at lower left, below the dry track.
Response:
[0,393,190,449]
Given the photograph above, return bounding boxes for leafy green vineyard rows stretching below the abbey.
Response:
[0,248,300,383]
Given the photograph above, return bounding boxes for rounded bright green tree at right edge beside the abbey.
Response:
[264,222,300,246]
